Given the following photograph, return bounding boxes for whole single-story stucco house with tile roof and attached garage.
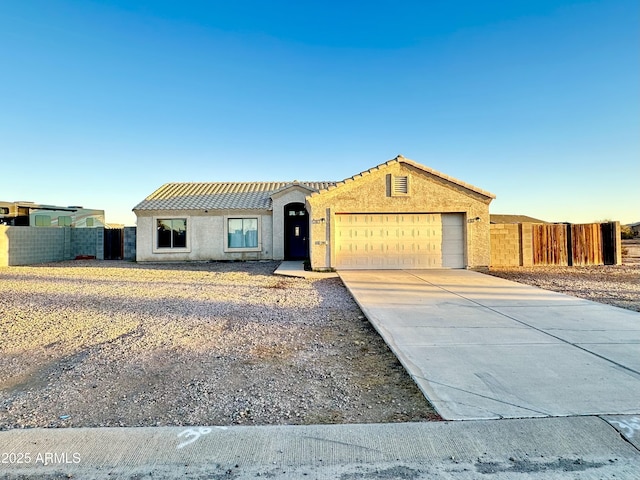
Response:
[133,156,495,270]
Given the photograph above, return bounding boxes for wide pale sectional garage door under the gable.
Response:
[335,213,464,270]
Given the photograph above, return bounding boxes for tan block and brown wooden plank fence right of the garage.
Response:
[491,222,622,266]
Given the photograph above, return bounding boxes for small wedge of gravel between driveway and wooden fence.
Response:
[489,263,640,312]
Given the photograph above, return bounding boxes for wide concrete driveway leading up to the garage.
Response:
[339,270,640,420]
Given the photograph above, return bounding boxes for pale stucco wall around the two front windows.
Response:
[136,210,273,262]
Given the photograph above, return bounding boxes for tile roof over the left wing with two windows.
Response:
[133,181,335,210]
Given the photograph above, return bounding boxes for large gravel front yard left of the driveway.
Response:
[0,261,439,429]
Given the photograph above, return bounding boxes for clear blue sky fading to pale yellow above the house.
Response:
[0,0,640,225]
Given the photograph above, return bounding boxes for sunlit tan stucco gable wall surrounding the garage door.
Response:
[307,162,491,270]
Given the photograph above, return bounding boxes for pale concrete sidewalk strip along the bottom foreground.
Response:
[0,417,640,480]
